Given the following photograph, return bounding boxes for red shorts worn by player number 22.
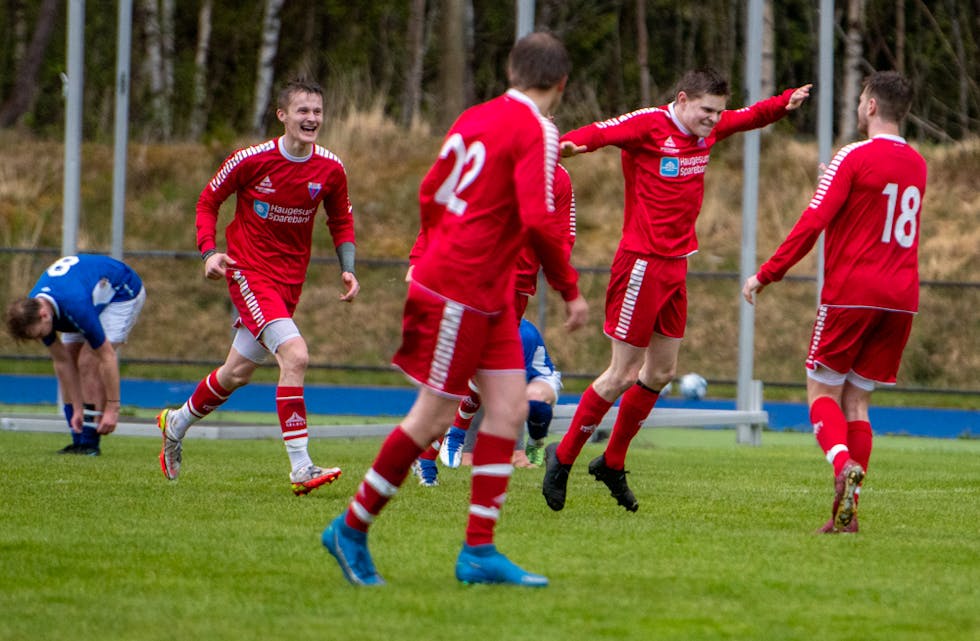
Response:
[392,283,524,398]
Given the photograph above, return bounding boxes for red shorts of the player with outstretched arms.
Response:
[603,249,687,348]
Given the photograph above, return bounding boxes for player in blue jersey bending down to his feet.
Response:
[7,254,146,456]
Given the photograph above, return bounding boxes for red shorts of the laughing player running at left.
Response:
[227,269,303,337]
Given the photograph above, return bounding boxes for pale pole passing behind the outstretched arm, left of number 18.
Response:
[736,0,762,445]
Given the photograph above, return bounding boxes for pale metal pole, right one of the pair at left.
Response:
[112,0,133,260]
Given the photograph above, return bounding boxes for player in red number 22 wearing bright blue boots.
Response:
[321,33,588,586]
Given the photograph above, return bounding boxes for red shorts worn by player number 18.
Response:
[806,305,914,385]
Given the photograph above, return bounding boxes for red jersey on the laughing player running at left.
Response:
[197,138,354,284]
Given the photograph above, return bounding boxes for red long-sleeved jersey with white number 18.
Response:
[757,135,926,312]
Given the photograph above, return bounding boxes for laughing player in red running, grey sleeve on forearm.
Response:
[157,76,360,495]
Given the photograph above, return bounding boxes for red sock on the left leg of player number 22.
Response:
[344,425,422,532]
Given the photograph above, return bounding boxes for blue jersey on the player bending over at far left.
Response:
[30,254,143,349]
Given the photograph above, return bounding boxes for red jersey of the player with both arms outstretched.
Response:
[561,89,793,258]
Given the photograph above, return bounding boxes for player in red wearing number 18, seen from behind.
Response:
[742,71,926,533]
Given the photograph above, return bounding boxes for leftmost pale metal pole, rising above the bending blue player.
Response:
[61,0,85,256]
